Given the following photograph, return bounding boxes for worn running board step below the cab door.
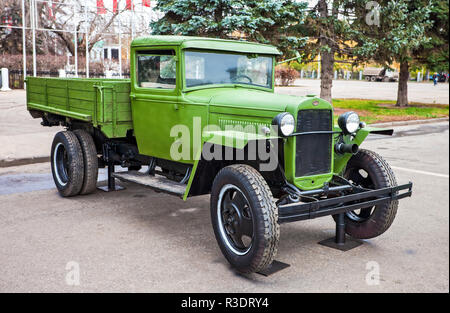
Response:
[112,171,186,197]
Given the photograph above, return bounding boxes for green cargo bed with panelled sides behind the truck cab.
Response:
[27,77,133,138]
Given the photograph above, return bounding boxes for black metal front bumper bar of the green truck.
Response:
[278,182,413,224]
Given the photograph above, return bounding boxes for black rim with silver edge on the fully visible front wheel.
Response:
[217,185,254,255]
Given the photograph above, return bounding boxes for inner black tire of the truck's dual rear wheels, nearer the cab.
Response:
[74,129,98,195]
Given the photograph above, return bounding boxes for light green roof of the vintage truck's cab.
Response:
[131,36,281,55]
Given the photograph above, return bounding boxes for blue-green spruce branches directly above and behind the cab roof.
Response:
[150,0,306,57]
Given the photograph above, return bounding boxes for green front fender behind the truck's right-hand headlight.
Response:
[333,127,394,175]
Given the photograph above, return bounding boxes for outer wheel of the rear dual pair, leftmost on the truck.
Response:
[51,131,84,197]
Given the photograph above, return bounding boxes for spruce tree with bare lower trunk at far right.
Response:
[352,0,433,106]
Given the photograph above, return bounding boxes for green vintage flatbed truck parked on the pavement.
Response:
[27,36,412,273]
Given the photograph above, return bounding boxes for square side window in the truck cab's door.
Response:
[136,50,177,89]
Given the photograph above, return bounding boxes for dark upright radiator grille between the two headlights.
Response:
[295,110,333,177]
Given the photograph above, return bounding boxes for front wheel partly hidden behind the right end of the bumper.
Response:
[340,149,398,239]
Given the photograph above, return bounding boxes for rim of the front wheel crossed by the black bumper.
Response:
[345,168,375,223]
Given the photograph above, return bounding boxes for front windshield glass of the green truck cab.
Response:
[185,51,273,88]
